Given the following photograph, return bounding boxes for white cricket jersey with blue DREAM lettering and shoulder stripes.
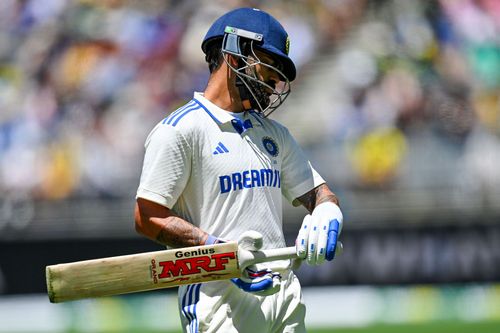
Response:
[137,93,324,248]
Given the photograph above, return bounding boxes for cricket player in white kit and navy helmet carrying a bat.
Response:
[135,8,343,332]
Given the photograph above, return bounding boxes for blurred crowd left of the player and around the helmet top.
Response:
[0,0,360,199]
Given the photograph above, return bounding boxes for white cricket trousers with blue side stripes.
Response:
[179,271,306,333]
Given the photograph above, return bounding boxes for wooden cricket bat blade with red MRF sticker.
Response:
[45,242,240,303]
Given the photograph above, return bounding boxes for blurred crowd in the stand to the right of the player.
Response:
[279,0,500,195]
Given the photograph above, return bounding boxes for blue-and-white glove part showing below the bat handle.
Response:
[231,267,281,296]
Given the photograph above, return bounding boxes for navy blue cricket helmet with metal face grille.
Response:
[201,8,297,117]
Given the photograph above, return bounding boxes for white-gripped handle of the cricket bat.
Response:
[238,242,344,271]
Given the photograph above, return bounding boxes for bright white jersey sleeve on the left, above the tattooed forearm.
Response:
[136,123,191,208]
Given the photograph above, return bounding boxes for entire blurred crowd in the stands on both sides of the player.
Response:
[0,0,500,199]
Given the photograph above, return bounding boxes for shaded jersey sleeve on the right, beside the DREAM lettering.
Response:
[281,130,325,206]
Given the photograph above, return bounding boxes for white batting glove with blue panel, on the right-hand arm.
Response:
[295,202,344,266]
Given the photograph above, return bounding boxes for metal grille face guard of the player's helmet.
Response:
[222,26,290,118]
